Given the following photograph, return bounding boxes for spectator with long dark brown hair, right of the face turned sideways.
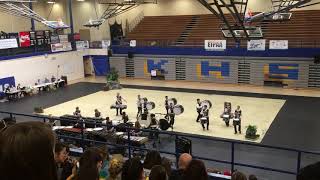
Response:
[70,148,103,180]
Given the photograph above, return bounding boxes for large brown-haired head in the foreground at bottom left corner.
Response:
[0,122,57,180]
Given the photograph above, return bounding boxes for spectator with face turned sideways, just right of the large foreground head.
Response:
[54,142,76,180]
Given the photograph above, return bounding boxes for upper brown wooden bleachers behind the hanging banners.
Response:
[126,10,320,48]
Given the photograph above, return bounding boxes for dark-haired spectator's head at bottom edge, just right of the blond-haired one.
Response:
[122,157,144,180]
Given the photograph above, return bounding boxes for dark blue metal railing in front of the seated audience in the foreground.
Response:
[0,111,320,179]
